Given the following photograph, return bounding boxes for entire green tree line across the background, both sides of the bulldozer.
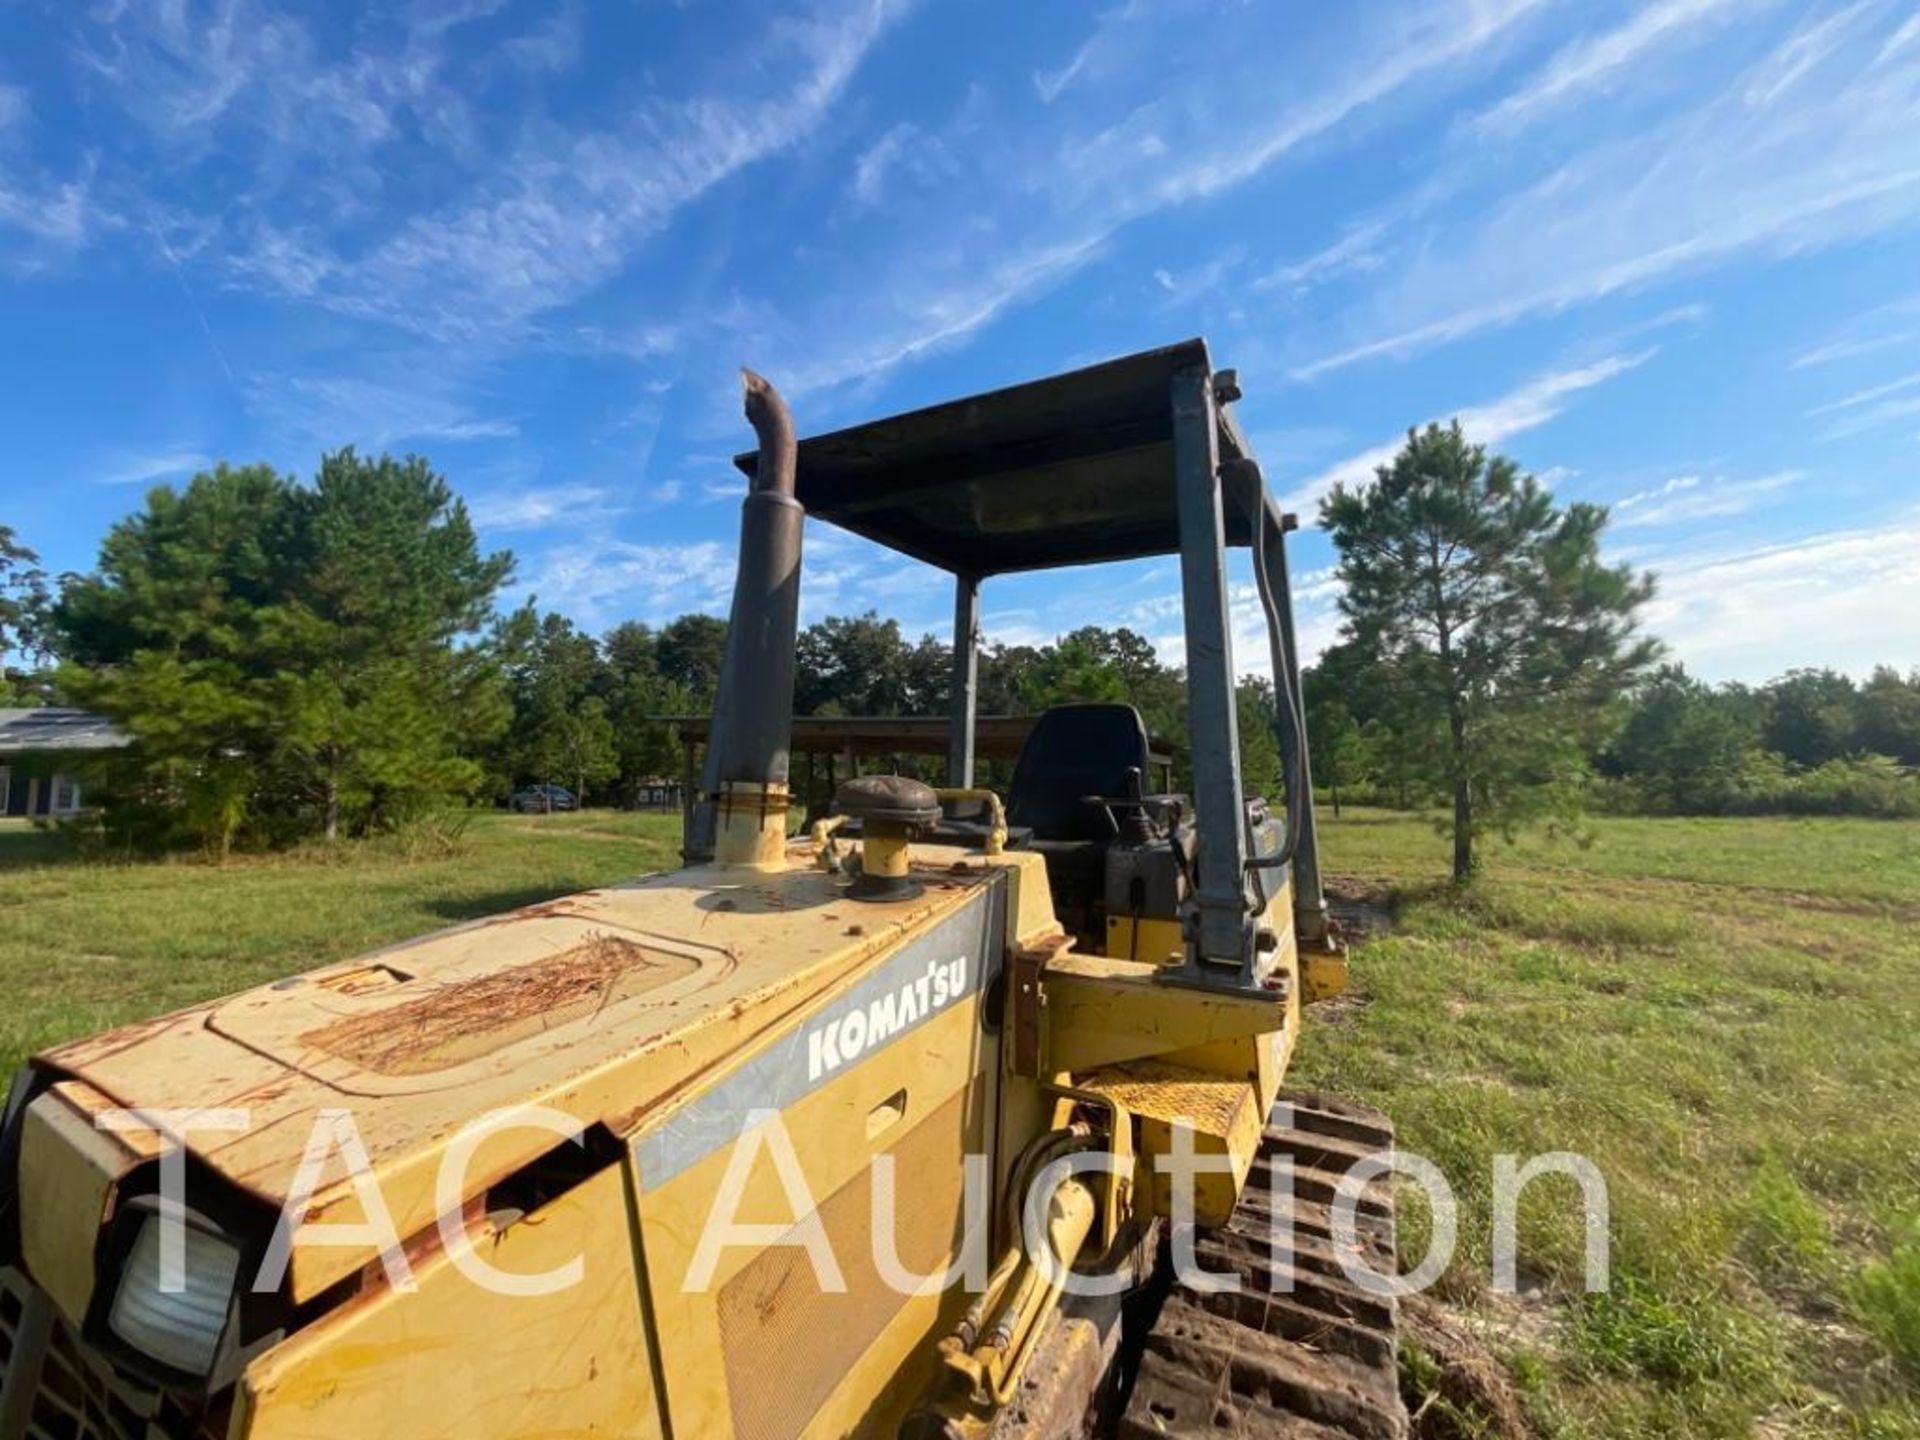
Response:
[0,424,1920,877]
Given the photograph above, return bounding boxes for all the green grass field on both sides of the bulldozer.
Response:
[0,812,1920,1436]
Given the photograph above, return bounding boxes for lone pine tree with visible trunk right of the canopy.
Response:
[1321,420,1657,881]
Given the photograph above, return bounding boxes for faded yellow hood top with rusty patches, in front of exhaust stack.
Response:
[36,854,1031,1294]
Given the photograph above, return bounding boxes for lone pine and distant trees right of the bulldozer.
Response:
[1304,422,1920,879]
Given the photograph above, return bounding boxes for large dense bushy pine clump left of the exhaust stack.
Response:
[54,449,513,854]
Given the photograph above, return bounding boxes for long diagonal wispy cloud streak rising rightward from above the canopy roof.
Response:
[758,0,1544,403]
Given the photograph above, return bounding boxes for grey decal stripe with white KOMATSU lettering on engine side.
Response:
[636,898,1006,1188]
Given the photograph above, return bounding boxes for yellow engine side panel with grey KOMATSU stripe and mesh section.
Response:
[636,885,1006,1440]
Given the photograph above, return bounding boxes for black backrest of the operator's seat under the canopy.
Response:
[1006,705,1148,841]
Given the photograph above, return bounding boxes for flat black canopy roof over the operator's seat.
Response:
[733,340,1248,576]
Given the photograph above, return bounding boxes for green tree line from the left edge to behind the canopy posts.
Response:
[0,449,1277,856]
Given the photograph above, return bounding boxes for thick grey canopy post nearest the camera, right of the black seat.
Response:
[1171,365,1254,985]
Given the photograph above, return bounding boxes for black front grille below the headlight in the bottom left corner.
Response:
[0,1271,227,1440]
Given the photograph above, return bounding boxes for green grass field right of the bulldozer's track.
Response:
[1296,812,1920,1436]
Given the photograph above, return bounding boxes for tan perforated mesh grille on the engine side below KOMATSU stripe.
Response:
[720,1085,979,1440]
